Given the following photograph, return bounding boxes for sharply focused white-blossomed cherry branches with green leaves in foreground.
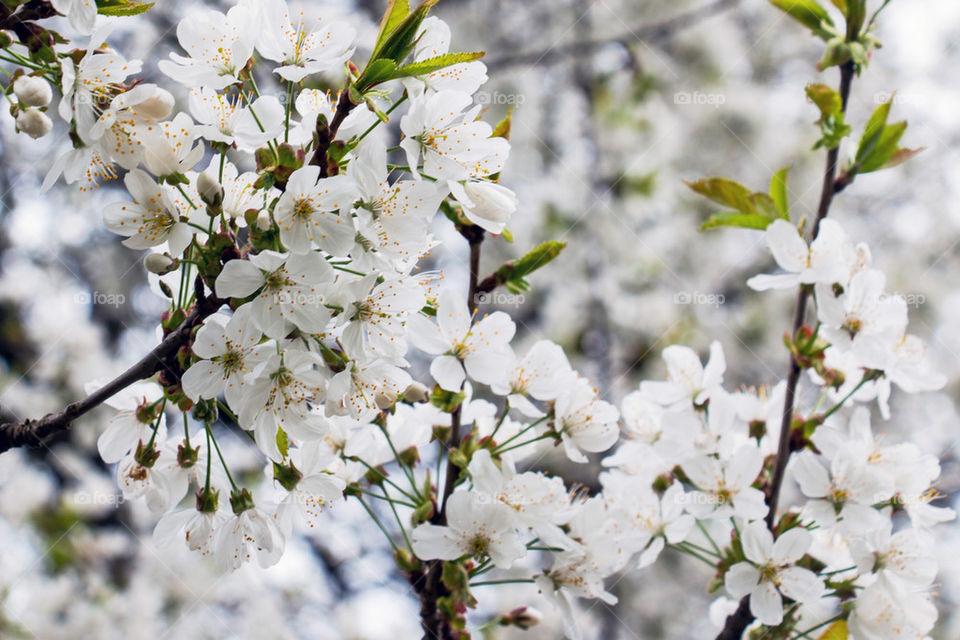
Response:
[0,0,954,640]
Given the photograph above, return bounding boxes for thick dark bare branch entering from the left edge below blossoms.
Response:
[0,285,224,453]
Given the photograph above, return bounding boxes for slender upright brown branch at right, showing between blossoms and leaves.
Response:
[716,62,854,640]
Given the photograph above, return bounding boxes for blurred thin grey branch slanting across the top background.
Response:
[486,0,739,71]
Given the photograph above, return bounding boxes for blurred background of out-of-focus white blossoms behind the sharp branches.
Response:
[0,0,960,640]
